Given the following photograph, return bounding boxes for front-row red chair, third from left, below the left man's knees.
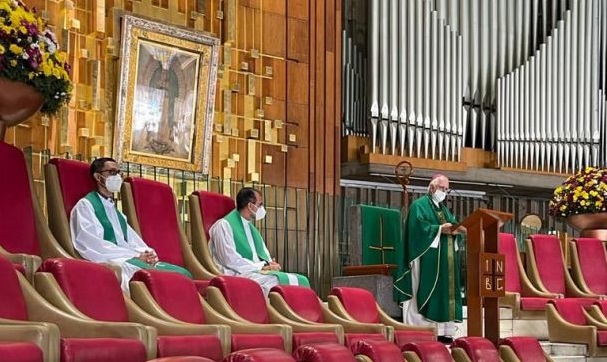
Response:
[130,269,292,352]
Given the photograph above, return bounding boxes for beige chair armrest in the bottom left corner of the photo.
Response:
[0,318,61,362]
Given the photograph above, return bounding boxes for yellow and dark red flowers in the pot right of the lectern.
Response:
[549,167,607,217]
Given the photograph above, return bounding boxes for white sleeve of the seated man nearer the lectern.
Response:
[209,219,264,274]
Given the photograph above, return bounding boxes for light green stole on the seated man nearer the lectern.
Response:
[225,209,310,287]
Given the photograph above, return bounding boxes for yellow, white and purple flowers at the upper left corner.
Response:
[0,0,72,115]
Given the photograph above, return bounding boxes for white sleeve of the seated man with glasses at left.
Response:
[70,199,140,264]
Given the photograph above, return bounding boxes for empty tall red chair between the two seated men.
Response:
[121,177,215,295]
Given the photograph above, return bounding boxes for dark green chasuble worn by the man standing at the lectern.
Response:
[394,195,462,322]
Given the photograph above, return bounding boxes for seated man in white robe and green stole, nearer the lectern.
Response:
[209,187,310,296]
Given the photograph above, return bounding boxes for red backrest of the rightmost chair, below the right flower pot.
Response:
[573,238,607,295]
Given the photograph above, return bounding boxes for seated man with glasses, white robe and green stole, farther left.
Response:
[70,157,192,293]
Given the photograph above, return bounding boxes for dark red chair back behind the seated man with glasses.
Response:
[44,158,95,258]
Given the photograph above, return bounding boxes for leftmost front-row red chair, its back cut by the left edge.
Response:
[0,257,150,362]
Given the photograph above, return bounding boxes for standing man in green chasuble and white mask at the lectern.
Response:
[394,175,466,342]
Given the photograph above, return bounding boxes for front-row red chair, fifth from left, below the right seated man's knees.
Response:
[269,285,408,361]
